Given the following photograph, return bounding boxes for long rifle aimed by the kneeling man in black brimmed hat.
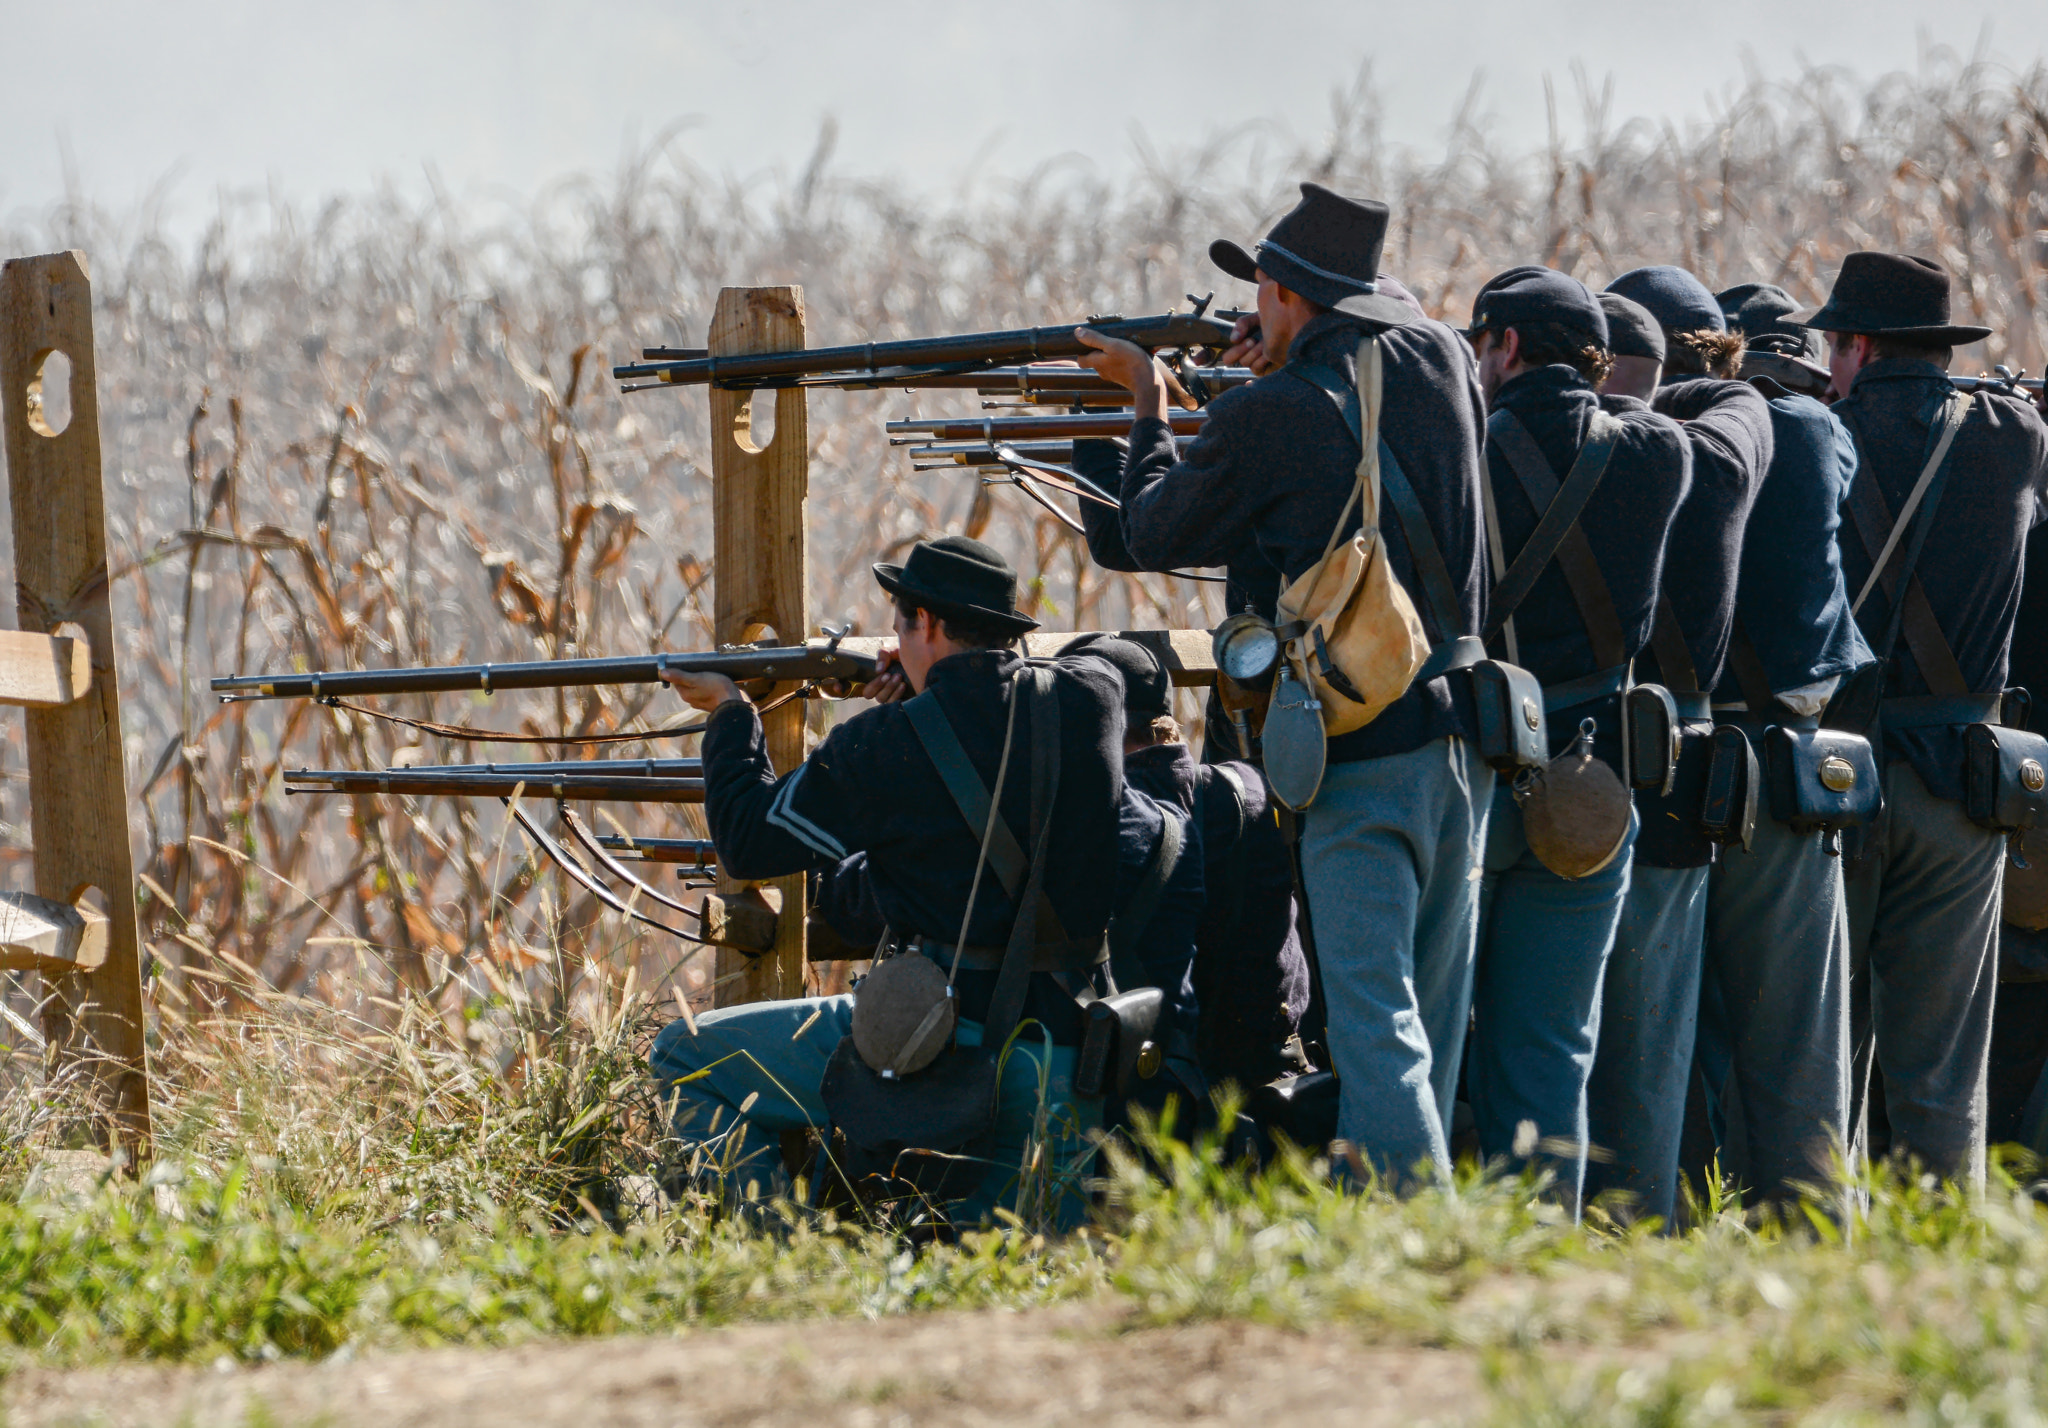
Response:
[213,639,874,699]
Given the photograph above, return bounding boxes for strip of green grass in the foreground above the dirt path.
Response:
[12,1122,2048,1428]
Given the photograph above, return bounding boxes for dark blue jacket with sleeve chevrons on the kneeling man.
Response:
[702,649,1122,1035]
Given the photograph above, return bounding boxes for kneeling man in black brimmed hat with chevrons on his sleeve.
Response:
[651,537,1202,1217]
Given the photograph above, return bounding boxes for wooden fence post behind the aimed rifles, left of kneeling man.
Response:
[707,287,811,1006]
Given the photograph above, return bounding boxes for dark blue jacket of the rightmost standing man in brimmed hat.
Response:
[1835,359,2048,799]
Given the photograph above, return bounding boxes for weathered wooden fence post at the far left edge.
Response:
[0,252,150,1166]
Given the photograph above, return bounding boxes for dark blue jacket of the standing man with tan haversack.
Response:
[1090,313,1487,762]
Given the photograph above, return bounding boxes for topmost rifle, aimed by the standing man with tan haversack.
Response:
[612,313,1231,389]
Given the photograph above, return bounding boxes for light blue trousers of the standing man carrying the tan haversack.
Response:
[1300,738,1493,1182]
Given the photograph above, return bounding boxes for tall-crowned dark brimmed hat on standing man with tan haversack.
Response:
[1208,184,1415,328]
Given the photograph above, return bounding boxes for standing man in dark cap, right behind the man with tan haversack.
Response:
[1466,268,1690,1205]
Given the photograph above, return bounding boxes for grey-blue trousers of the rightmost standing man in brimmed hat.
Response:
[1845,762,2005,1186]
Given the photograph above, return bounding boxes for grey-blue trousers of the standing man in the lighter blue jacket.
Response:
[1698,817,1849,1199]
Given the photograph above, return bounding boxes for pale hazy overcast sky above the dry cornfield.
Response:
[0,0,2048,227]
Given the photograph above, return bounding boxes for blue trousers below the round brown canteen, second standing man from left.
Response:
[1464,785,1636,1211]
